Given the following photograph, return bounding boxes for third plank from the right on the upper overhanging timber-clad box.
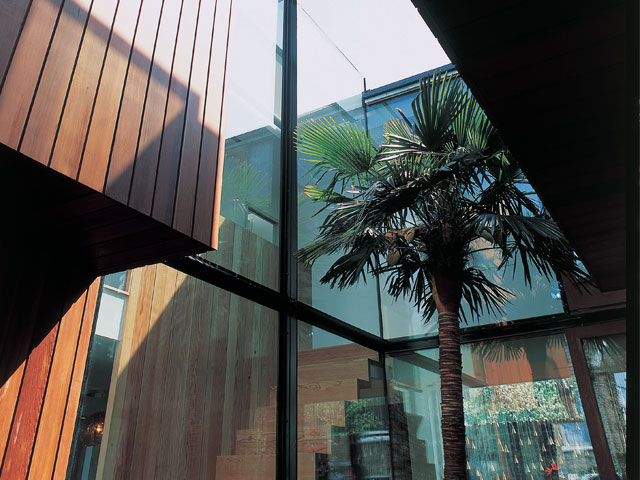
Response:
[151,0,200,226]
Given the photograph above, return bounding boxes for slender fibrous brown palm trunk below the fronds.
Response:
[432,272,467,480]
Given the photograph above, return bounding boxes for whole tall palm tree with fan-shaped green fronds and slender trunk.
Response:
[296,69,587,480]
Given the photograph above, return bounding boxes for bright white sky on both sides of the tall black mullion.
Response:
[226,0,450,137]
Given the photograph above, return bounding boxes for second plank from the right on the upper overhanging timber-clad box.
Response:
[173,0,216,235]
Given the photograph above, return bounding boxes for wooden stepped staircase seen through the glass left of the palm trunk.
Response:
[215,345,384,480]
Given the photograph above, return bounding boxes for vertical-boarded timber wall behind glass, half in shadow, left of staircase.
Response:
[93,227,277,479]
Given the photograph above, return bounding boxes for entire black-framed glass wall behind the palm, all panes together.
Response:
[62,0,626,480]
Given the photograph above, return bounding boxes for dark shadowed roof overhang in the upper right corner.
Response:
[413,0,628,291]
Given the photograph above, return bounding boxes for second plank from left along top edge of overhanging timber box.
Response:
[0,0,62,150]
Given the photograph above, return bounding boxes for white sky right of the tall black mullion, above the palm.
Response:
[298,0,451,113]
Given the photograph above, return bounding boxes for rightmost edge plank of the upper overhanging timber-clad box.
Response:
[193,0,231,244]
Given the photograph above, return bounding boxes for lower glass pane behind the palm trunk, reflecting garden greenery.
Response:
[387,335,598,480]
